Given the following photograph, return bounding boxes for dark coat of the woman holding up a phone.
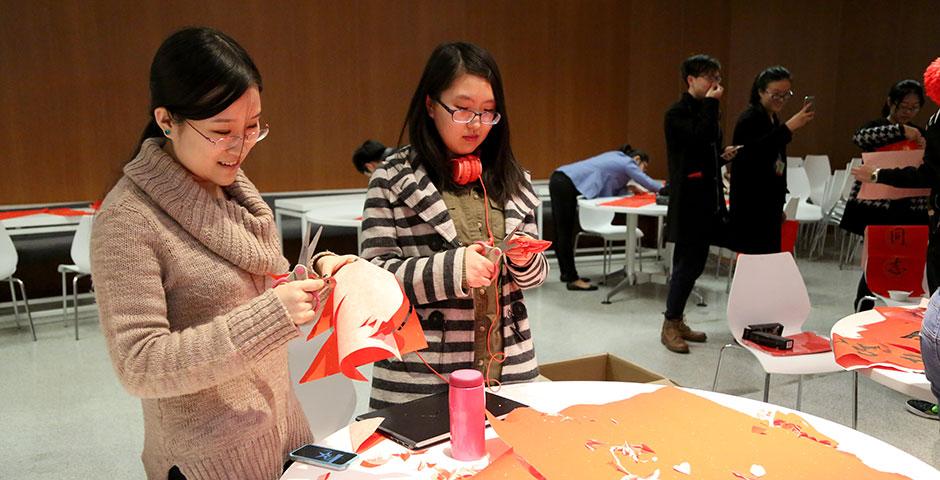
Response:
[730,105,793,254]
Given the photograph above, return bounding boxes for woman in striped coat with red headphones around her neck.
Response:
[362,43,548,408]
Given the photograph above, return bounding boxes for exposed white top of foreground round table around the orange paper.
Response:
[281,382,940,480]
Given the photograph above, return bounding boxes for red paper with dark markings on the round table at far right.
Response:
[832,307,925,373]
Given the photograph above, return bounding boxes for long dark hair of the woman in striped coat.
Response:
[398,42,525,203]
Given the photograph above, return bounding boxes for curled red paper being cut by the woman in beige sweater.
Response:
[300,260,428,383]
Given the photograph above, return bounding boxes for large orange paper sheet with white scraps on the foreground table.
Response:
[484,387,907,480]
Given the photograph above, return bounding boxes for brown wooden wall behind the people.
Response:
[0,0,940,205]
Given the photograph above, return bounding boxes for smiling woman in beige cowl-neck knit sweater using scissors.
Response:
[92,28,355,479]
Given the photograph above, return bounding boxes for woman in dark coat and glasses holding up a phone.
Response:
[730,66,815,254]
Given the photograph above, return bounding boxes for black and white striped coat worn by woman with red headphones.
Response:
[361,148,548,408]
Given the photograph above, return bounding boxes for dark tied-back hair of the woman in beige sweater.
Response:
[134,27,262,156]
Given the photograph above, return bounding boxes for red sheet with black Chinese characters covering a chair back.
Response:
[862,225,929,297]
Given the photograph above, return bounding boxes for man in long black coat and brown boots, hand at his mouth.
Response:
[661,55,735,353]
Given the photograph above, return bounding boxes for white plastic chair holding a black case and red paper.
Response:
[712,252,842,410]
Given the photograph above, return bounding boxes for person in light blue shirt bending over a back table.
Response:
[548,145,662,290]
